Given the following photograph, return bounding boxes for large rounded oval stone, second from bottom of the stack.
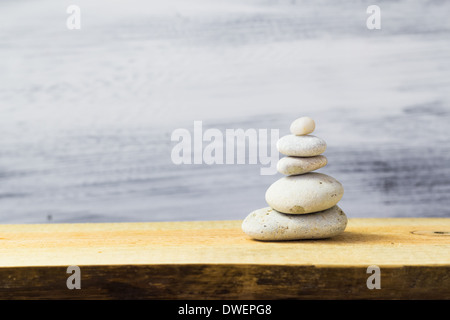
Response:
[266,172,344,214]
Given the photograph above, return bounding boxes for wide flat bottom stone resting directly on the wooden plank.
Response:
[242,206,347,241]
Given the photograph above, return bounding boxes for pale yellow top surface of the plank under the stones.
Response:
[0,218,450,268]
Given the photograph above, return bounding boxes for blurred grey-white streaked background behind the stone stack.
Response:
[0,0,450,223]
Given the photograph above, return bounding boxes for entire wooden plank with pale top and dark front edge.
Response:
[0,218,450,299]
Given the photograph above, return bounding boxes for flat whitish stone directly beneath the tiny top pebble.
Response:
[277,134,327,157]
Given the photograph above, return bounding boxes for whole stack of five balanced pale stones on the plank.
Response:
[242,117,347,241]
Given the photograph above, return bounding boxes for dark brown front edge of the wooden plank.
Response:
[0,264,450,300]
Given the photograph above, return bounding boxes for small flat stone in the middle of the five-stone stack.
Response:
[277,156,328,175]
